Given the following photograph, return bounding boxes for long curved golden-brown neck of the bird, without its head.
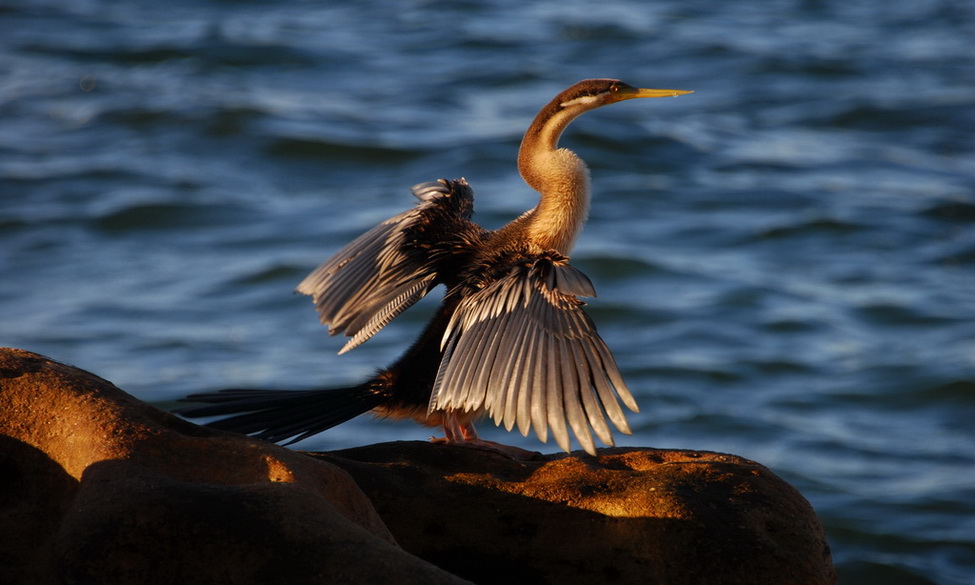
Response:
[518,100,590,255]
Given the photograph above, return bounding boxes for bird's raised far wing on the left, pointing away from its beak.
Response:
[296,179,480,354]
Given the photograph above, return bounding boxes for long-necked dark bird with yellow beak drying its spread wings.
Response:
[179,79,692,455]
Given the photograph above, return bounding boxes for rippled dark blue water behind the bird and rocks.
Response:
[0,0,975,585]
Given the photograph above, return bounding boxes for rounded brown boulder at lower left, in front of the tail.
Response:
[0,349,466,585]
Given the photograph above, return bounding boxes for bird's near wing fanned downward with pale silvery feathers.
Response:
[430,254,638,454]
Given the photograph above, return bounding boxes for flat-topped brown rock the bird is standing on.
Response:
[314,442,836,585]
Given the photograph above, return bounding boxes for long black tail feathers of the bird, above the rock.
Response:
[176,383,386,444]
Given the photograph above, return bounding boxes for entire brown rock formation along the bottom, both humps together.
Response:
[0,349,836,585]
